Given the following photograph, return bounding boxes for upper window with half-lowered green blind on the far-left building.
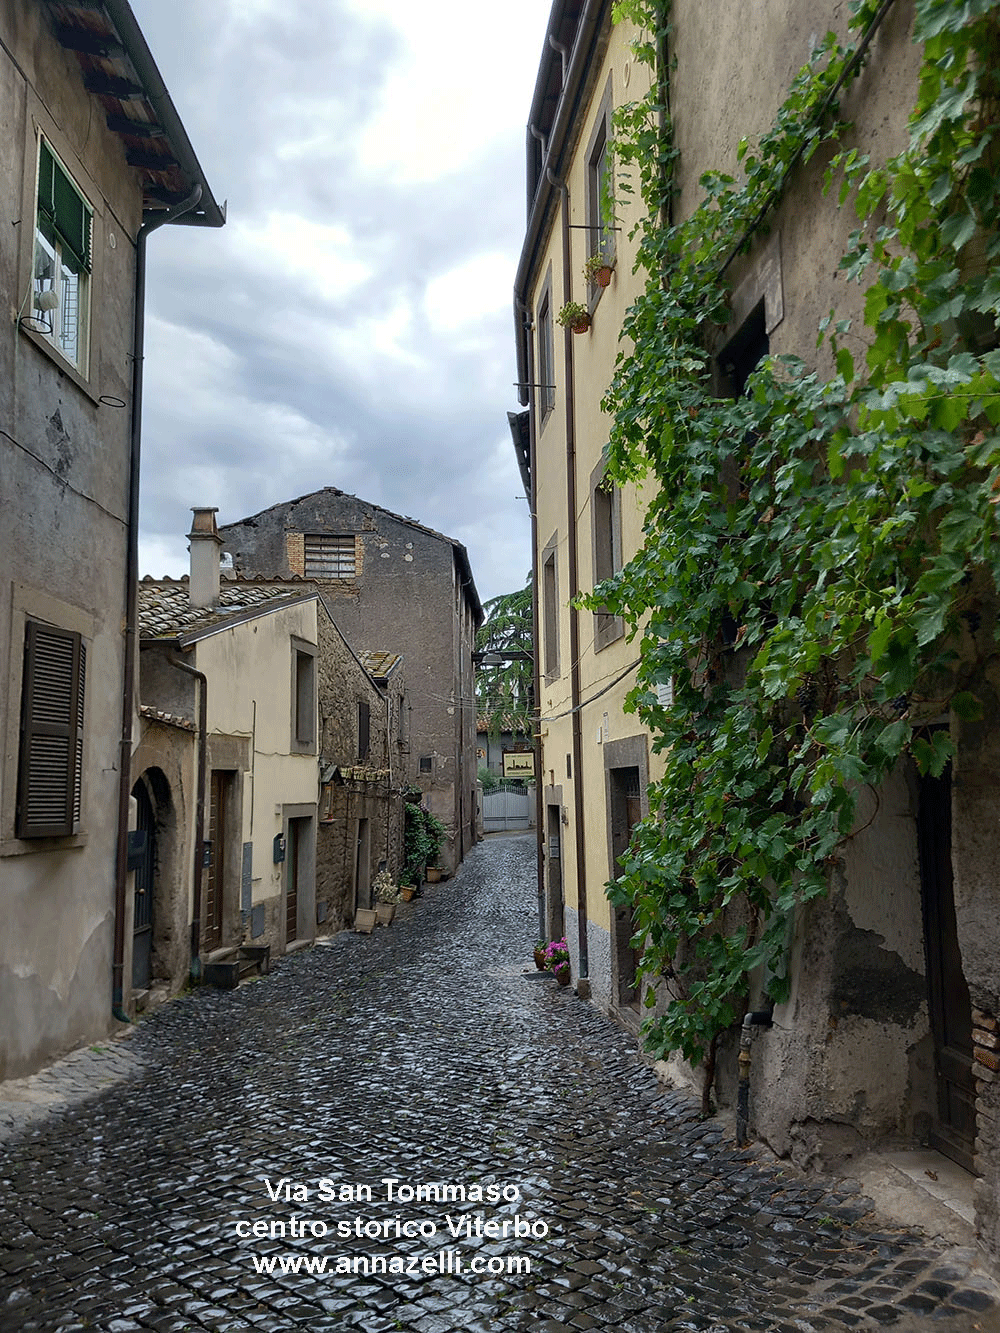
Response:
[28,139,93,375]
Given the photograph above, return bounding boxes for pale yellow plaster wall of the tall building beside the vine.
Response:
[528,24,658,981]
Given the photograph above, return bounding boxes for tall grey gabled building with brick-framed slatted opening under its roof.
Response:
[220,487,483,872]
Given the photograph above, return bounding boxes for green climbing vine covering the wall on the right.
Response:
[591,0,1000,1061]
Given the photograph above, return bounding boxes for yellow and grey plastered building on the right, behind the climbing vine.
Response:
[511,0,1000,1256]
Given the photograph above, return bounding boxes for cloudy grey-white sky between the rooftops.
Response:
[132,0,549,600]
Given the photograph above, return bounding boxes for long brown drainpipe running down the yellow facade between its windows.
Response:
[545,168,591,981]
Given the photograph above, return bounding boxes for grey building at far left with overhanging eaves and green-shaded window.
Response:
[0,0,224,1078]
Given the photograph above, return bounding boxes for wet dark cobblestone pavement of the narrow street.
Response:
[0,837,1000,1333]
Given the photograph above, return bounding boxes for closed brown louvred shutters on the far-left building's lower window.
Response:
[15,620,87,838]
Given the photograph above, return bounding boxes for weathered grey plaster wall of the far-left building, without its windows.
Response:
[0,0,141,1078]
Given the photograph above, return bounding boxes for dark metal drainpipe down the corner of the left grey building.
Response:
[111,185,201,1022]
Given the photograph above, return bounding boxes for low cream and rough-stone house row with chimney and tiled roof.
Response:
[129,509,403,1004]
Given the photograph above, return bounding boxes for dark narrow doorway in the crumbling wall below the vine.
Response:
[917,765,976,1170]
